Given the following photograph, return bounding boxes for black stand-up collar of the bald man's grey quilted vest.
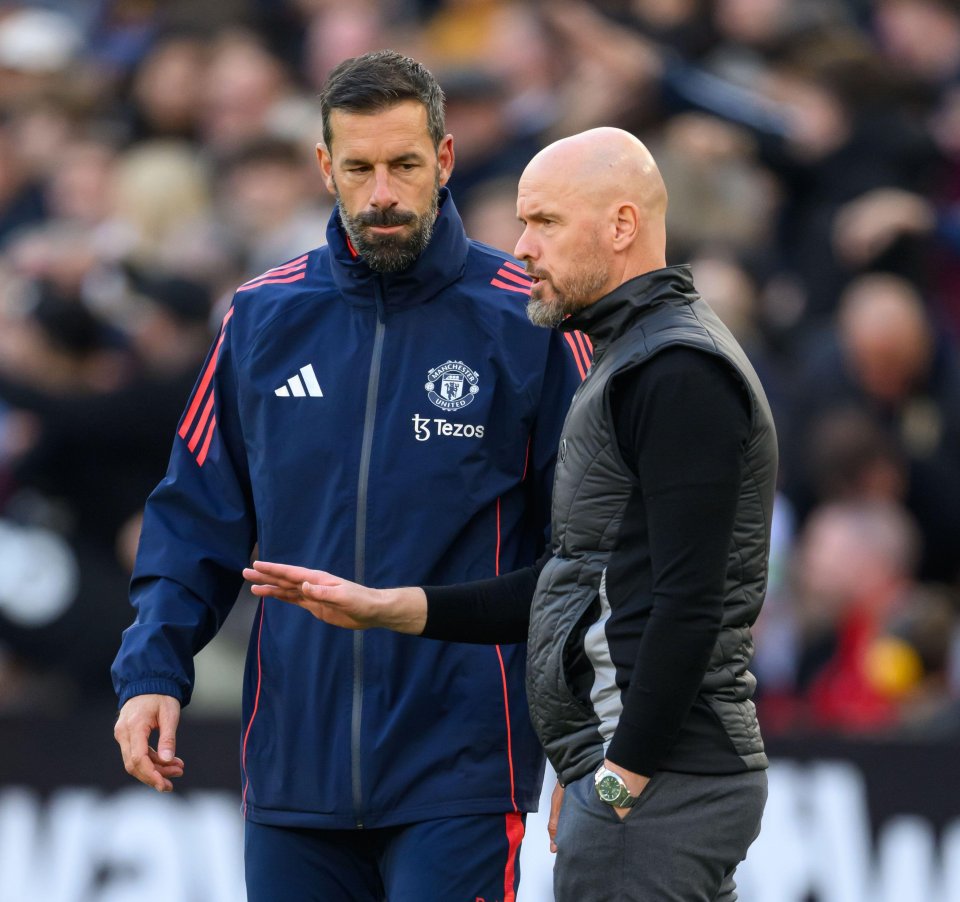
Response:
[560,263,699,356]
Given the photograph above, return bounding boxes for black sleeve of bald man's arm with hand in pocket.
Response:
[607,348,750,776]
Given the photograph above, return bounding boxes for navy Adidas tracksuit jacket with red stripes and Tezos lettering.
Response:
[113,189,588,828]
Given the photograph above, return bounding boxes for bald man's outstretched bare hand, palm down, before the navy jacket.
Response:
[243,561,427,636]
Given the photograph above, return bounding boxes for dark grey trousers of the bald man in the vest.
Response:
[553,771,767,902]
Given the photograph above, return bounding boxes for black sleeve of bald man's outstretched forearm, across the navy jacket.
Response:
[420,551,550,645]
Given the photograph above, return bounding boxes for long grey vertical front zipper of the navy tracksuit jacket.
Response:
[350,279,385,829]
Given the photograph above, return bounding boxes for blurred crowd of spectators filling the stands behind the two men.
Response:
[0,0,960,736]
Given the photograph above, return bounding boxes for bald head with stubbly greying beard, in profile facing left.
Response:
[515,128,667,325]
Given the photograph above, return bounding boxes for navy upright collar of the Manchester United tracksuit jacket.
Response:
[327,188,469,318]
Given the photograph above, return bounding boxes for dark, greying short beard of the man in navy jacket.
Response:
[334,170,440,272]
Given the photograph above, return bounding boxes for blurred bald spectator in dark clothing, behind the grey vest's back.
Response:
[778,273,960,583]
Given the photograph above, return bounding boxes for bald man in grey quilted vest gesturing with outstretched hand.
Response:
[245,128,777,902]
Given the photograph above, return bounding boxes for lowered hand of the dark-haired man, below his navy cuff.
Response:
[113,695,183,792]
